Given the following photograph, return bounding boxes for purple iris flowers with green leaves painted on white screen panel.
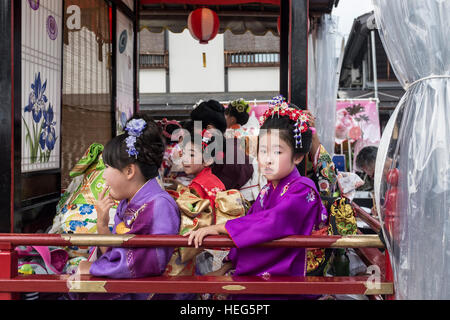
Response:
[23,72,57,163]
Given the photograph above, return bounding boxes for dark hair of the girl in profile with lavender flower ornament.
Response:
[103,113,165,180]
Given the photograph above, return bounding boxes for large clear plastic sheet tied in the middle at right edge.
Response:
[373,0,450,299]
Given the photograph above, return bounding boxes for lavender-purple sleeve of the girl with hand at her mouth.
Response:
[89,196,180,278]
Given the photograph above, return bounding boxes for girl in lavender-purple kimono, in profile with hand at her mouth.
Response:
[71,115,180,299]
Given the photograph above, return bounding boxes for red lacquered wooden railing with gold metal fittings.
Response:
[0,234,394,299]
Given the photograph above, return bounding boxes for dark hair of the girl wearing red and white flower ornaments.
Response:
[260,104,312,157]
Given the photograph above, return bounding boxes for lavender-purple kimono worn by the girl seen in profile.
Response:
[70,179,180,300]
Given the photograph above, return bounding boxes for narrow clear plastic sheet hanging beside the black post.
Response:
[308,14,338,154]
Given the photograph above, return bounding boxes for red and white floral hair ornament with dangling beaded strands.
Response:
[260,95,310,148]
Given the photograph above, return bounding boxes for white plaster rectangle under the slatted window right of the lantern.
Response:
[228,67,280,92]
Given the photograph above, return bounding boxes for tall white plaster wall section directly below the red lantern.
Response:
[169,29,225,92]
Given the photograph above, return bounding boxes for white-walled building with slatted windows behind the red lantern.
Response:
[139,29,280,118]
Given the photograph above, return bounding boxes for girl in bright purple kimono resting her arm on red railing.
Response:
[187,98,328,299]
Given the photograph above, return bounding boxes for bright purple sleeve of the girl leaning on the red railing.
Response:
[225,183,326,248]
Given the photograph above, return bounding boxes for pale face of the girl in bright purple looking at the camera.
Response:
[258,130,303,185]
